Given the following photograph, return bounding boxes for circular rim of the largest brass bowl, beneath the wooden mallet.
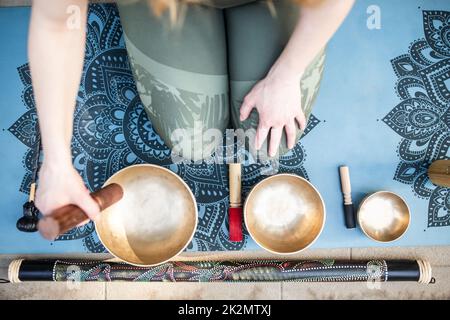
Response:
[94,163,198,267]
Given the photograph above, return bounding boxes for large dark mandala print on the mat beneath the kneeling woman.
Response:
[9,4,319,252]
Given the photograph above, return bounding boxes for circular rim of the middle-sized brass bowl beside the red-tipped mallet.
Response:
[243,173,327,256]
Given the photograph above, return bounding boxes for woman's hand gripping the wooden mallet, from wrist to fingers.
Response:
[36,160,100,220]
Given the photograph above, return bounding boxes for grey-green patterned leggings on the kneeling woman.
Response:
[119,0,324,160]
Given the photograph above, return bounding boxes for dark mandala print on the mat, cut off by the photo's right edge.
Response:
[383,11,450,227]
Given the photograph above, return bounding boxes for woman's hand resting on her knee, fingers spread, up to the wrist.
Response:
[240,68,306,157]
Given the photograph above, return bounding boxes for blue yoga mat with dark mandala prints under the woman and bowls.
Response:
[0,0,450,253]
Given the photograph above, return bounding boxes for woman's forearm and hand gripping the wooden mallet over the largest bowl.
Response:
[28,0,94,219]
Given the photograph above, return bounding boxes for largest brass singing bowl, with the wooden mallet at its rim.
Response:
[95,164,198,266]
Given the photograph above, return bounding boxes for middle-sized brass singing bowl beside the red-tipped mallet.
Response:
[244,174,325,254]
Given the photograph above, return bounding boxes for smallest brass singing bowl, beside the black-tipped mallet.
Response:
[358,191,411,242]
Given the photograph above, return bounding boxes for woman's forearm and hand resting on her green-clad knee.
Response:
[240,0,354,157]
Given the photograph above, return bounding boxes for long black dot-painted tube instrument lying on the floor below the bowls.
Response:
[8,259,433,283]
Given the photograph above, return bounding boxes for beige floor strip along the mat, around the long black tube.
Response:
[0,246,450,300]
